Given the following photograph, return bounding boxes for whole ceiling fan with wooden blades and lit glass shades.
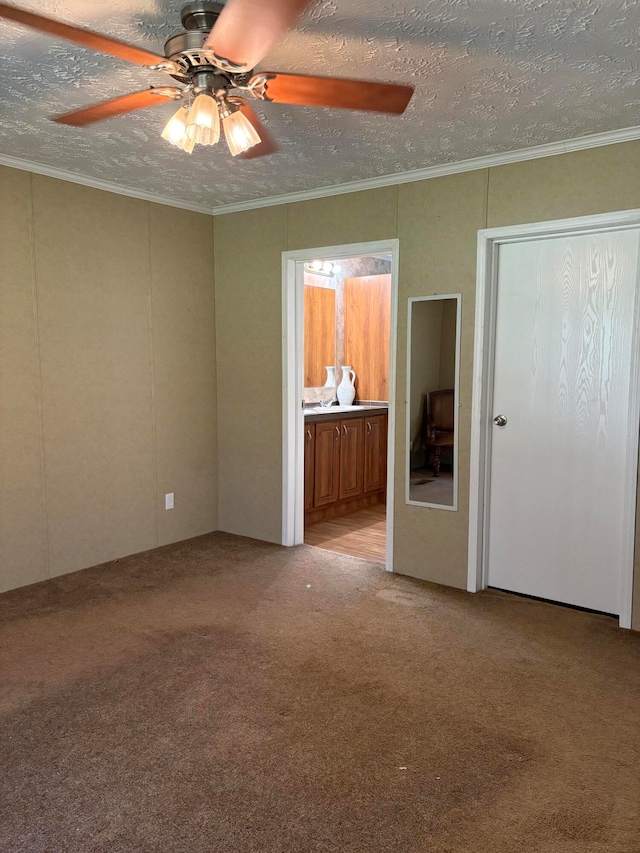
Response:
[0,0,413,159]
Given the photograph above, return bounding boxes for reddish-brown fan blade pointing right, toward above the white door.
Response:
[249,71,413,115]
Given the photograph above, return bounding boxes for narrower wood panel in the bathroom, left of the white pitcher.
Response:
[304,285,336,388]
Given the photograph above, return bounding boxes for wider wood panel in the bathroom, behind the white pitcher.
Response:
[344,275,391,400]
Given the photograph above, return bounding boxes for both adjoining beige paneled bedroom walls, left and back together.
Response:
[5,142,640,628]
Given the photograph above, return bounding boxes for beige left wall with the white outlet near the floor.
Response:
[0,168,217,589]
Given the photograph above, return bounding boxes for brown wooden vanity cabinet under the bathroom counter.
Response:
[304,412,387,524]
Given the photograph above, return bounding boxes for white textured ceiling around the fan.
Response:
[0,0,640,207]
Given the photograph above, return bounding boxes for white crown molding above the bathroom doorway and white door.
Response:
[210,126,640,216]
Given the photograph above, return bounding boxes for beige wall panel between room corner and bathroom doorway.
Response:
[215,206,288,542]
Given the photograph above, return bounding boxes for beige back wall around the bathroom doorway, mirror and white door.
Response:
[215,142,640,628]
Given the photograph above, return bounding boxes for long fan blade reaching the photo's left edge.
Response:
[0,3,180,73]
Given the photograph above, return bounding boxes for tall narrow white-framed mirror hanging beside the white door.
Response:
[406,294,462,510]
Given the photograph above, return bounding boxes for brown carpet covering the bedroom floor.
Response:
[0,534,640,853]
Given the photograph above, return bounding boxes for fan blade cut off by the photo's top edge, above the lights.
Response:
[205,0,310,71]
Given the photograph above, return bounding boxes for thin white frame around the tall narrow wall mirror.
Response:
[404,293,462,512]
